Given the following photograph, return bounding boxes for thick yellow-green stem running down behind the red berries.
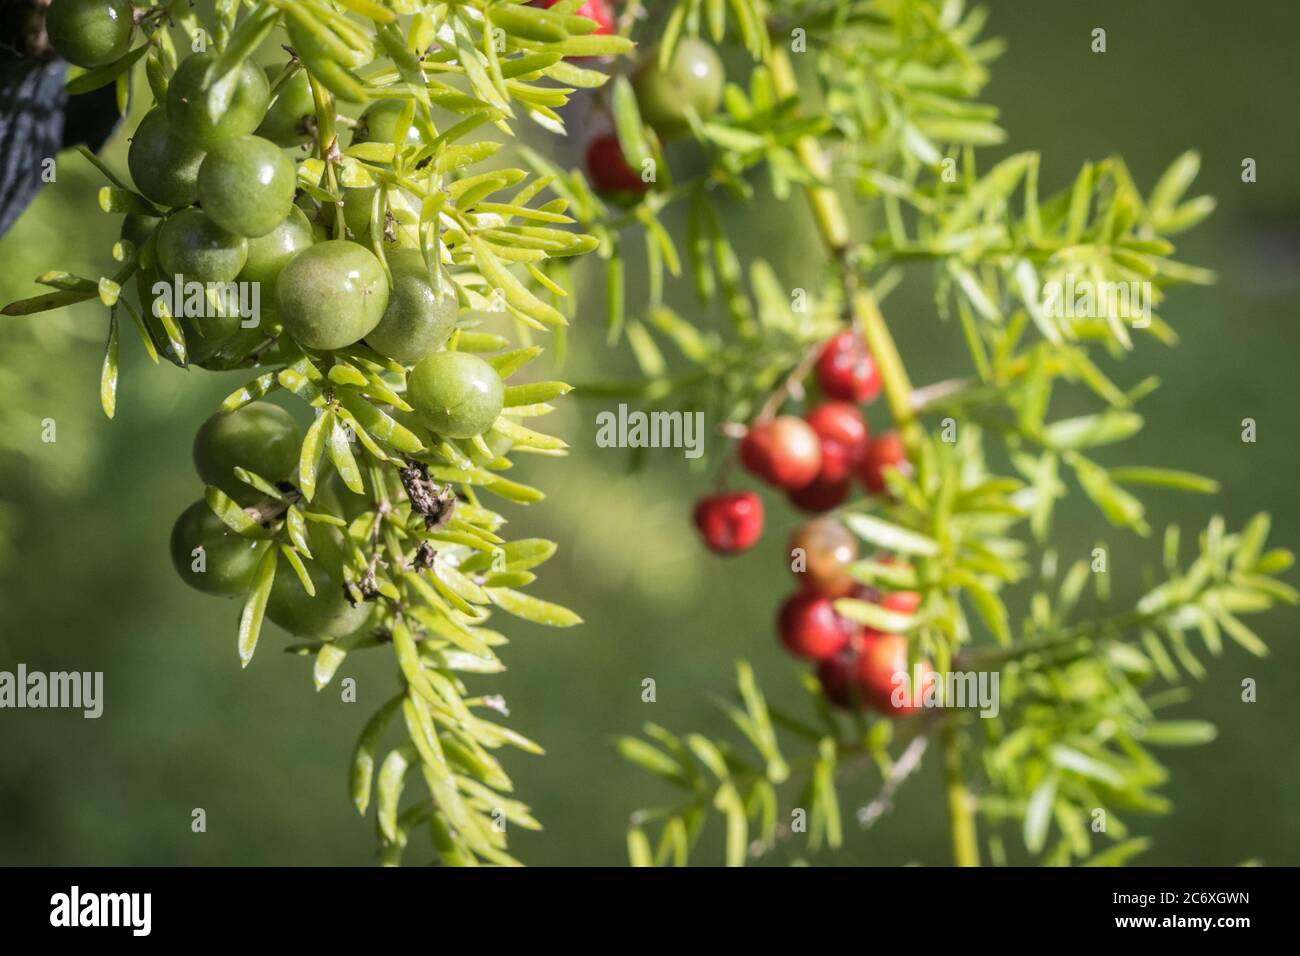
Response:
[767,38,979,866]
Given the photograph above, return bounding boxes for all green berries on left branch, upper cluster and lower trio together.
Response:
[47,0,522,629]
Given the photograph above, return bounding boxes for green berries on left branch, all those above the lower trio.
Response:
[47,0,503,426]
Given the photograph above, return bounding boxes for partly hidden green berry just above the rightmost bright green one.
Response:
[365,248,458,365]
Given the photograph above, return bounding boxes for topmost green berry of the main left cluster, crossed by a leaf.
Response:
[166,52,270,150]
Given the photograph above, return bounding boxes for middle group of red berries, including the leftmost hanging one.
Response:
[696,332,907,554]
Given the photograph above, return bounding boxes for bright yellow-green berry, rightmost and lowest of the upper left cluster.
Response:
[407,352,504,438]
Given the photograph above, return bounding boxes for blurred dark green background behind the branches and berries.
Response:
[0,0,1300,865]
